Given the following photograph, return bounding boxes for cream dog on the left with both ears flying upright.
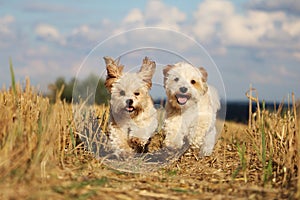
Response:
[104,57,158,154]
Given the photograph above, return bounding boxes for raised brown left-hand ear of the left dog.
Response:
[104,56,124,92]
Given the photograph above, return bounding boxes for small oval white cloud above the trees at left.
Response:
[35,24,66,45]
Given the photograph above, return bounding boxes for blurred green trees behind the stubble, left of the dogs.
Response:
[48,74,109,104]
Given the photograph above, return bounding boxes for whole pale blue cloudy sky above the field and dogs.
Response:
[0,0,300,101]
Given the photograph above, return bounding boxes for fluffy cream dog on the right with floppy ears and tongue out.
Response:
[163,62,220,156]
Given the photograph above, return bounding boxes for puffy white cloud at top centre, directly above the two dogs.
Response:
[105,0,190,51]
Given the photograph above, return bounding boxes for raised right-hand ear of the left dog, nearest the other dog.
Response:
[138,57,156,89]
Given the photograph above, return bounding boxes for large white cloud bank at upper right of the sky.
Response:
[193,0,300,48]
